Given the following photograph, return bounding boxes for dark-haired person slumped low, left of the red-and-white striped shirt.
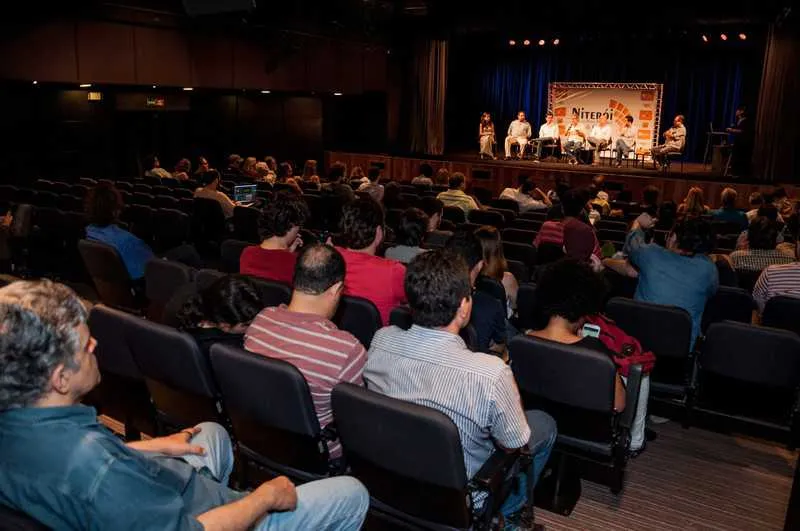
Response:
[176,275,264,356]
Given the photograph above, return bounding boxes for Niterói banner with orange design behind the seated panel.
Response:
[548,83,663,152]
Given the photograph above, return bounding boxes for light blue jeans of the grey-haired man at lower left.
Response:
[183,422,369,531]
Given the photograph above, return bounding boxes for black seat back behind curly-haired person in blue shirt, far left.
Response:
[78,240,138,310]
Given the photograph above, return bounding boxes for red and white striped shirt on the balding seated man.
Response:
[244,305,367,458]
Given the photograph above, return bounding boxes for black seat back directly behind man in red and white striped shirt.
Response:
[211,344,328,481]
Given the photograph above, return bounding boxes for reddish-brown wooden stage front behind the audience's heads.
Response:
[325,151,788,208]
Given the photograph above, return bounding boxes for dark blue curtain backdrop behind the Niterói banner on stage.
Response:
[447,36,763,160]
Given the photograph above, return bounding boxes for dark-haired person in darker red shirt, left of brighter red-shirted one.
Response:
[239,193,310,285]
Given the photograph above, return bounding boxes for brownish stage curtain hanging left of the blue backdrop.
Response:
[410,40,448,155]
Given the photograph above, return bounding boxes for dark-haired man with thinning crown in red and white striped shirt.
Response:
[244,244,367,459]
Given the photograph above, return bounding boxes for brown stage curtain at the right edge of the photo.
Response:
[753,21,800,181]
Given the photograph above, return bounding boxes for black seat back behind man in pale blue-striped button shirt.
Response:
[332,383,470,528]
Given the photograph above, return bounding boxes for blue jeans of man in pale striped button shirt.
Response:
[500,409,558,516]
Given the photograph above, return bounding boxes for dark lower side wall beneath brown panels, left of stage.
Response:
[0,84,386,182]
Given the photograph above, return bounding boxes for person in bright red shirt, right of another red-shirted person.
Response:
[337,199,406,325]
